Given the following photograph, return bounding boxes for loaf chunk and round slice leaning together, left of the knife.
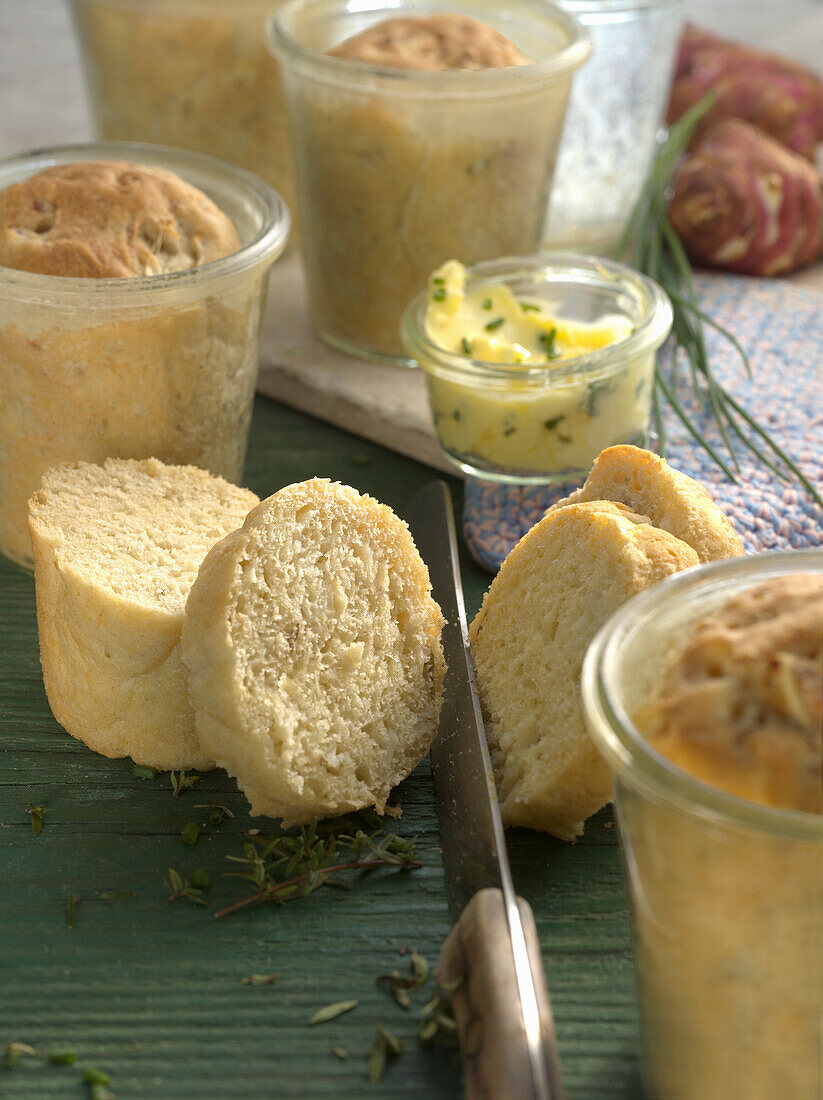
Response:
[30,459,445,823]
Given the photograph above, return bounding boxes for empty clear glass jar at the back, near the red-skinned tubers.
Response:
[546,0,684,253]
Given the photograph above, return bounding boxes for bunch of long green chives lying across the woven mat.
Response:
[616,92,823,507]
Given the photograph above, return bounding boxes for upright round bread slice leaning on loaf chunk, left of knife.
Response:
[183,480,445,825]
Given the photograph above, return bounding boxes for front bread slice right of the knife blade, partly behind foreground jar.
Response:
[470,501,700,839]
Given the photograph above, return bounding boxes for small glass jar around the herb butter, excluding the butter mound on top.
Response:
[403,252,671,484]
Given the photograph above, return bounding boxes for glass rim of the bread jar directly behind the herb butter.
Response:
[266,0,592,97]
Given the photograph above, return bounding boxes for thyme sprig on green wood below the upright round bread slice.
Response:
[215,818,421,919]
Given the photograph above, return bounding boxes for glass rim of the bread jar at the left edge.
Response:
[0,142,292,308]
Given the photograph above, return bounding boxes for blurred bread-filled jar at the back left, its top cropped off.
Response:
[72,0,294,215]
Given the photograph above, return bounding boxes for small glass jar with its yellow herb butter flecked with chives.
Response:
[402,252,671,484]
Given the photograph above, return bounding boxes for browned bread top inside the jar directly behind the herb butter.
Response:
[328,12,531,73]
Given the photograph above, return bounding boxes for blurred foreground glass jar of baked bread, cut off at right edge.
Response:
[581,550,823,1100]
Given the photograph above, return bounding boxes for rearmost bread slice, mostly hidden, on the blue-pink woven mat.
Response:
[549,443,745,561]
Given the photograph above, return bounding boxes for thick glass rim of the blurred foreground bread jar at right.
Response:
[581,549,823,843]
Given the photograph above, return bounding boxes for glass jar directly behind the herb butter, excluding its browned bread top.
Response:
[270,0,590,362]
